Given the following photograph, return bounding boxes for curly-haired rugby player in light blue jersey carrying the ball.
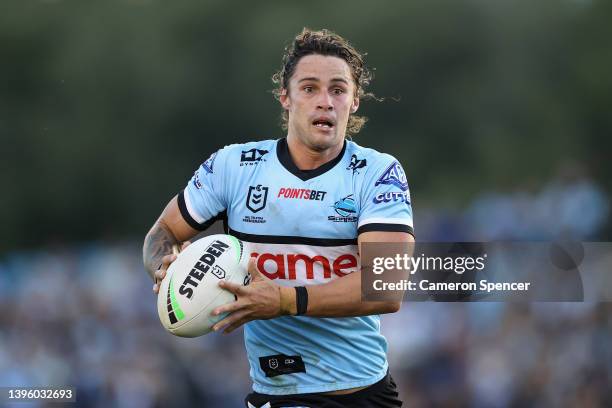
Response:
[143,29,414,407]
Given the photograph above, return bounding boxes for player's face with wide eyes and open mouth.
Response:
[280,54,359,151]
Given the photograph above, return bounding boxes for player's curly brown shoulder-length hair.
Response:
[272,28,376,136]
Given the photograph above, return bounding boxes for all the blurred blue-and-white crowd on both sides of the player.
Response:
[0,171,612,408]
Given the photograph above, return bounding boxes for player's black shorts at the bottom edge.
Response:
[244,373,402,408]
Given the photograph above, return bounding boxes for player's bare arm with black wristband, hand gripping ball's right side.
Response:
[213,231,414,333]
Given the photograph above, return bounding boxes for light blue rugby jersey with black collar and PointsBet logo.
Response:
[178,139,413,395]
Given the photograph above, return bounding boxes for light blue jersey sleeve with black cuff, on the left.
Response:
[178,147,229,231]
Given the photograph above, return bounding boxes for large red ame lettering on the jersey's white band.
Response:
[251,252,357,280]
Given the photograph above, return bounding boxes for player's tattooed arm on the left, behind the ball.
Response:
[142,196,199,283]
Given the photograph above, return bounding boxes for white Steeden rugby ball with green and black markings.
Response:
[157,234,251,337]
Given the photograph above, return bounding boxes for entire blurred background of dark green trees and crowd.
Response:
[0,0,612,407]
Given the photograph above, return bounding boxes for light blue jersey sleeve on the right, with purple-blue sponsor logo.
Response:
[357,154,414,236]
